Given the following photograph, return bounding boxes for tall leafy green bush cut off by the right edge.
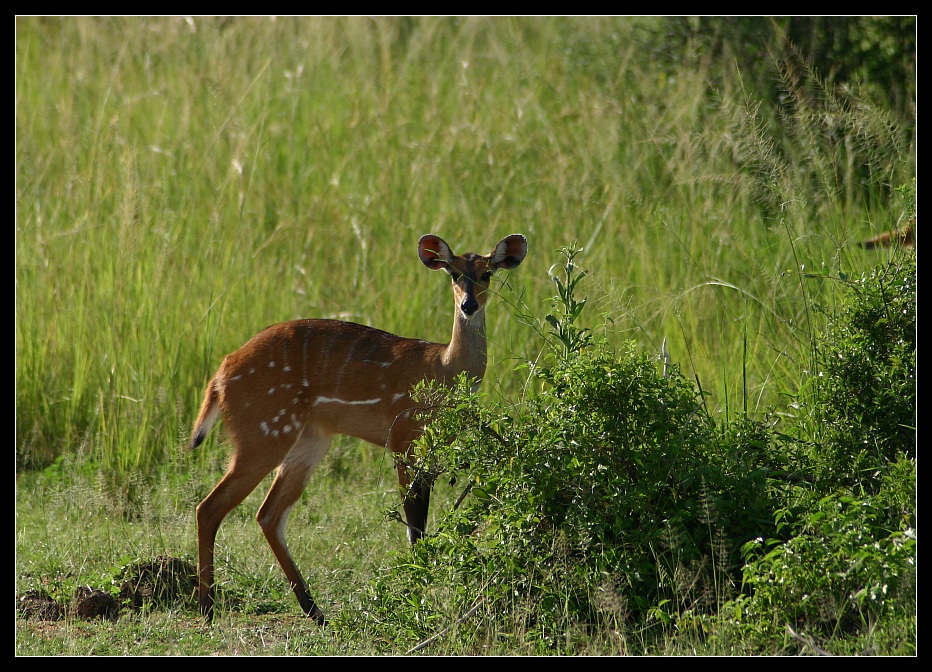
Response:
[736,247,916,646]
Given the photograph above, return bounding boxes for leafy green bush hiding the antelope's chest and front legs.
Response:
[362,253,774,650]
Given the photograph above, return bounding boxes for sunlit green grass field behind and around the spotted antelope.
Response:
[14,17,916,655]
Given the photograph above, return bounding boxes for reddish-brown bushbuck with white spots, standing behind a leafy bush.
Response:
[190,234,527,623]
